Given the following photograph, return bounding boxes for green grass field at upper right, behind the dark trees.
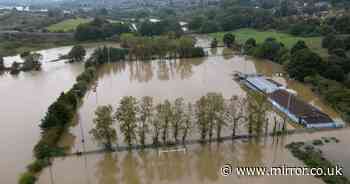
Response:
[209,29,328,57]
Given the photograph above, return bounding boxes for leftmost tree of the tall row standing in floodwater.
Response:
[90,105,117,150]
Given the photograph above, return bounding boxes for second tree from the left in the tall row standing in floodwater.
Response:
[115,96,138,146]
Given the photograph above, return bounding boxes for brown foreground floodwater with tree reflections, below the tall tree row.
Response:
[39,137,323,184]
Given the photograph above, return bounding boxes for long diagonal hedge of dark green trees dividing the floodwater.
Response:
[19,47,126,184]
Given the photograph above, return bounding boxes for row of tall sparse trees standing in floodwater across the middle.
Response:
[90,93,278,150]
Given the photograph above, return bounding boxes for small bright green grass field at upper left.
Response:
[47,18,91,32]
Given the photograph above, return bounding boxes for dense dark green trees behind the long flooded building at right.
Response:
[244,35,350,121]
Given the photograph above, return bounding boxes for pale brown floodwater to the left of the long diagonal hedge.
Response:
[0,44,119,184]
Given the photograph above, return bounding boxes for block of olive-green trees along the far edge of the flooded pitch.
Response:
[120,34,205,60]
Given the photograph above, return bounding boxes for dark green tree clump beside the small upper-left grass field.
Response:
[75,18,131,41]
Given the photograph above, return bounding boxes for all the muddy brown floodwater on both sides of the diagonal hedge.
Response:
[0,37,350,184]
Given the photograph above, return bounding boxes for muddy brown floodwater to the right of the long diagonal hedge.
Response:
[39,45,348,184]
